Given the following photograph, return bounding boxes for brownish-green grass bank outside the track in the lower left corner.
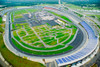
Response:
[0,34,45,67]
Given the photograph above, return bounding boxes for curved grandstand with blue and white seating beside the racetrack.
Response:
[56,21,98,66]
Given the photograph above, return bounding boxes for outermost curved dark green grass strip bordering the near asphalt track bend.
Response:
[12,38,73,55]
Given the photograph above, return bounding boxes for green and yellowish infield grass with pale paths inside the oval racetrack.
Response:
[11,9,77,55]
